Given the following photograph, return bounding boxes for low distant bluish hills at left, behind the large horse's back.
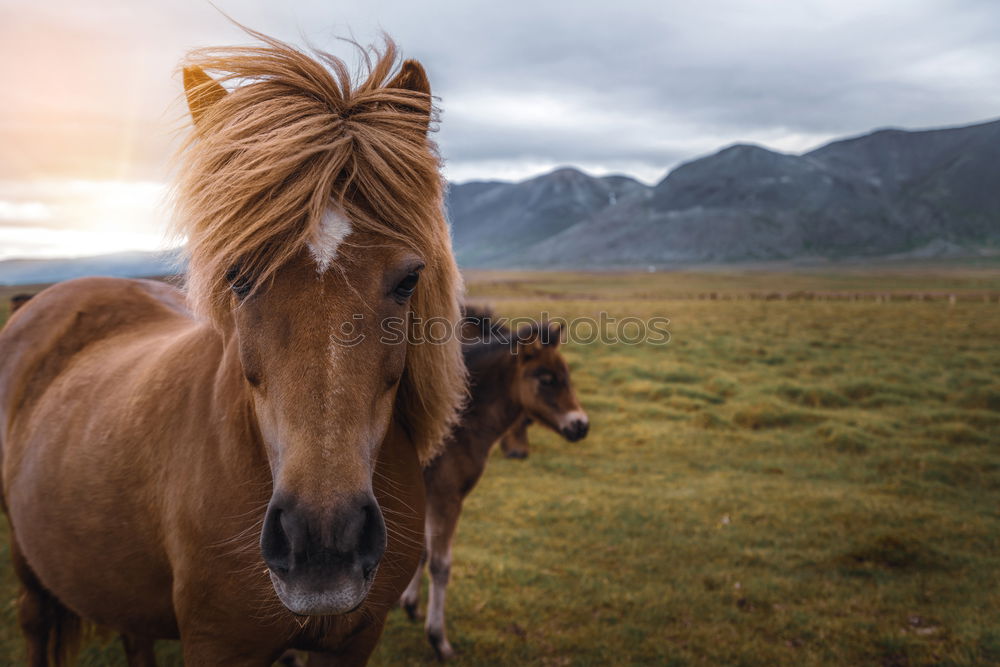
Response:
[0,251,181,285]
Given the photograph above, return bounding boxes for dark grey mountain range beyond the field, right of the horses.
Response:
[448,120,1000,268]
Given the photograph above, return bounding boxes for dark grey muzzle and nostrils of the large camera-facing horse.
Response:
[260,493,386,616]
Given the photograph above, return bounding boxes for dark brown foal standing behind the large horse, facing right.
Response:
[400,307,589,660]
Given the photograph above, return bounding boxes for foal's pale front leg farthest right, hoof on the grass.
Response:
[425,501,462,660]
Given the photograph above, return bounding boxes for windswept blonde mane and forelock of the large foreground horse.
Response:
[175,31,465,462]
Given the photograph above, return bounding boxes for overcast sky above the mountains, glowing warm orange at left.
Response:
[0,0,1000,257]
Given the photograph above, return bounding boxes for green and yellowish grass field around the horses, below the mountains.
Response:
[0,268,1000,666]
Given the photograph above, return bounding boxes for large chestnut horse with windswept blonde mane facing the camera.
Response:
[0,33,465,666]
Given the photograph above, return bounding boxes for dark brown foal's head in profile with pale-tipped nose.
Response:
[514,322,590,442]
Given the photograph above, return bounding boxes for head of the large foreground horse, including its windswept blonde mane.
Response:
[177,33,464,615]
